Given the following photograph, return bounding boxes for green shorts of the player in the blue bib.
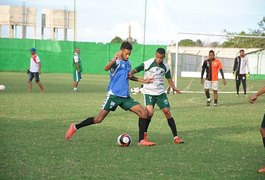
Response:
[101,94,139,111]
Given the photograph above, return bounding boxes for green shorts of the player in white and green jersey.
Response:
[144,93,170,109]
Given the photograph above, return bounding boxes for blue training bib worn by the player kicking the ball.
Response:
[108,58,131,97]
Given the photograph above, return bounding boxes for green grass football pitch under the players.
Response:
[0,72,265,180]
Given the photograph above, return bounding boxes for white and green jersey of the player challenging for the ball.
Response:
[135,58,171,95]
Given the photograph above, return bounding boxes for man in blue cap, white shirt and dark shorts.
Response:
[28,48,45,92]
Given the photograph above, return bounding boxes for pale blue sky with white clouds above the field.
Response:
[0,0,265,44]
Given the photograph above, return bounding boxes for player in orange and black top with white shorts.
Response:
[201,50,226,107]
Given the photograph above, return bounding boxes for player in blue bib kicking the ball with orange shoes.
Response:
[65,41,154,146]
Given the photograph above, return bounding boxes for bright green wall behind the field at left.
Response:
[0,38,166,74]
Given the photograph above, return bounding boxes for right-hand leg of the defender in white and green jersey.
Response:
[157,93,184,144]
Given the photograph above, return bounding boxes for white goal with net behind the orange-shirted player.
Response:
[167,33,265,93]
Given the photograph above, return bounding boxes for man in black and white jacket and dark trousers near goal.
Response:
[233,49,250,97]
